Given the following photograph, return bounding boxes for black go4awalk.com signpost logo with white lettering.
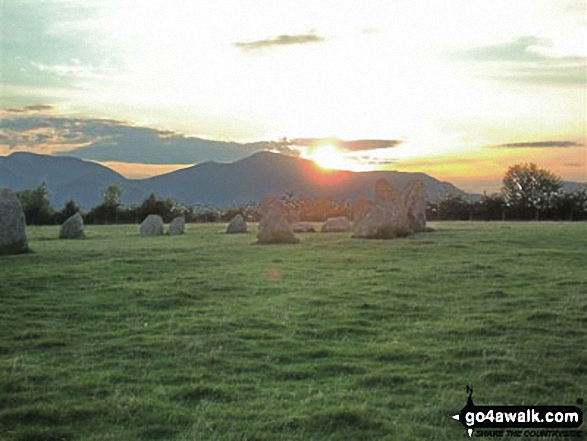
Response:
[452,386,583,438]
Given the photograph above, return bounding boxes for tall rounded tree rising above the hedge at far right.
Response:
[502,163,562,220]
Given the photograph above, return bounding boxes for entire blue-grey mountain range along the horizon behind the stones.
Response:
[0,151,473,210]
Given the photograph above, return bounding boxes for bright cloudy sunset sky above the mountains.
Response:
[0,0,587,192]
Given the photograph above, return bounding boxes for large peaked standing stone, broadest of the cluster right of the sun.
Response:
[353,179,411,239]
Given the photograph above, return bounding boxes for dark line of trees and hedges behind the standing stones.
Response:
[12,163,587,225]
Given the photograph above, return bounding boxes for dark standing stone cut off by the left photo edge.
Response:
[0,188,29,255]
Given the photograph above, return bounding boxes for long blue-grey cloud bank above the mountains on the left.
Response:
[0,105,284,165]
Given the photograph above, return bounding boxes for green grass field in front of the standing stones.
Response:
[0,222,587,441]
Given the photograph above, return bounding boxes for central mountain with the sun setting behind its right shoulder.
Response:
[145,152,467,206]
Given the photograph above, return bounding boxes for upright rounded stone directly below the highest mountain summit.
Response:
[257,198,298,244]
